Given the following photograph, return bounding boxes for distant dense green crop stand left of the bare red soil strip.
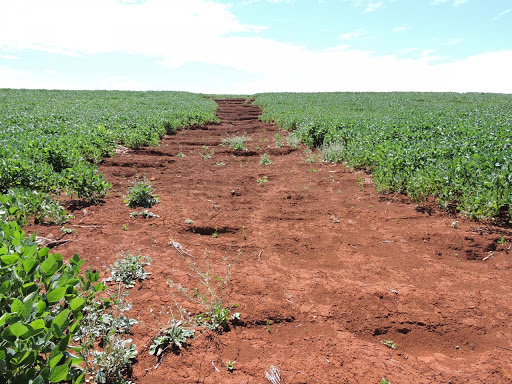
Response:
[0,89,217,222]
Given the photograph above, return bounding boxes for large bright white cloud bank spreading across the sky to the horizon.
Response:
[0,0,512,93]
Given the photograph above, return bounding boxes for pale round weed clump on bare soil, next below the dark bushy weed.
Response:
[106,253,151,288]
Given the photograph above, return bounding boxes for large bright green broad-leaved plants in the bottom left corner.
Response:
[0,222,100,384]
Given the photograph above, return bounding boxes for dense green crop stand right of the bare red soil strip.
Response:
[255,93,512,219]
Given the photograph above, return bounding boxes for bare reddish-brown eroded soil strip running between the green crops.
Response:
[27,100,512,384]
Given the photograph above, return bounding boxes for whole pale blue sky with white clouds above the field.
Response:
[0,0,512,93]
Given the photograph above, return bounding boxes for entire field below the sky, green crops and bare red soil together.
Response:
[0,89,512,384]
